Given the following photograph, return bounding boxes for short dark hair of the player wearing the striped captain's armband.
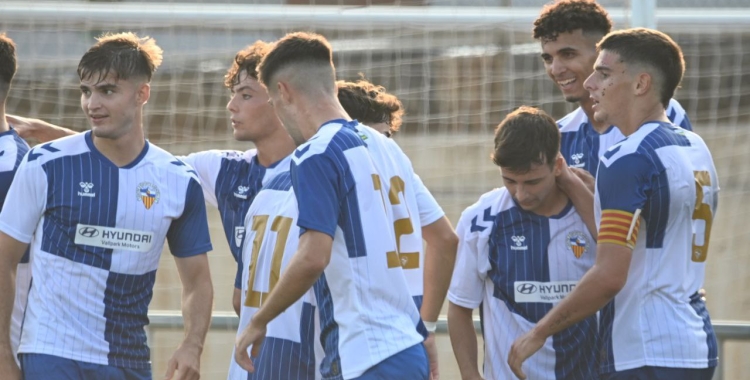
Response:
[596,28,685,108]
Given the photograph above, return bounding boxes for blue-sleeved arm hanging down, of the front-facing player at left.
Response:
[165,177,214,379]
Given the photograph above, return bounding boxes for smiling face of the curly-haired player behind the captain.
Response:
[542,29,600,102]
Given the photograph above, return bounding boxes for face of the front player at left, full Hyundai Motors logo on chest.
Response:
[81,73,150,140]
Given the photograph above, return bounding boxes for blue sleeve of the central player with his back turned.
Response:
[290,154,346,238]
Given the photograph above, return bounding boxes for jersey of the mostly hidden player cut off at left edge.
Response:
[0,127,31,360]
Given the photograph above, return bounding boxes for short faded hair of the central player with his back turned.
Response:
[258,32,333,86]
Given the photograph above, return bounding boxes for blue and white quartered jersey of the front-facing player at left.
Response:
[0,132,211,369]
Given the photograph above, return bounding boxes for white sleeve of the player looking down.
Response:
[448,208,488,309]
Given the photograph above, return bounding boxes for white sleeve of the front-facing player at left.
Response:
[0,150,48,243]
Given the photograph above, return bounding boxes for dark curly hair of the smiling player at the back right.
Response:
[533,0,612,41]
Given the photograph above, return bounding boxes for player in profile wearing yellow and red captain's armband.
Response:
[508,28,718,380]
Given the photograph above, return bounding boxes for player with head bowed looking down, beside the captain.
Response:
[448,107,597,379]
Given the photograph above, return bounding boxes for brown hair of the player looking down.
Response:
[492,106,560,173]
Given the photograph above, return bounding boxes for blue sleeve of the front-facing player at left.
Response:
[167,178,213,257]
